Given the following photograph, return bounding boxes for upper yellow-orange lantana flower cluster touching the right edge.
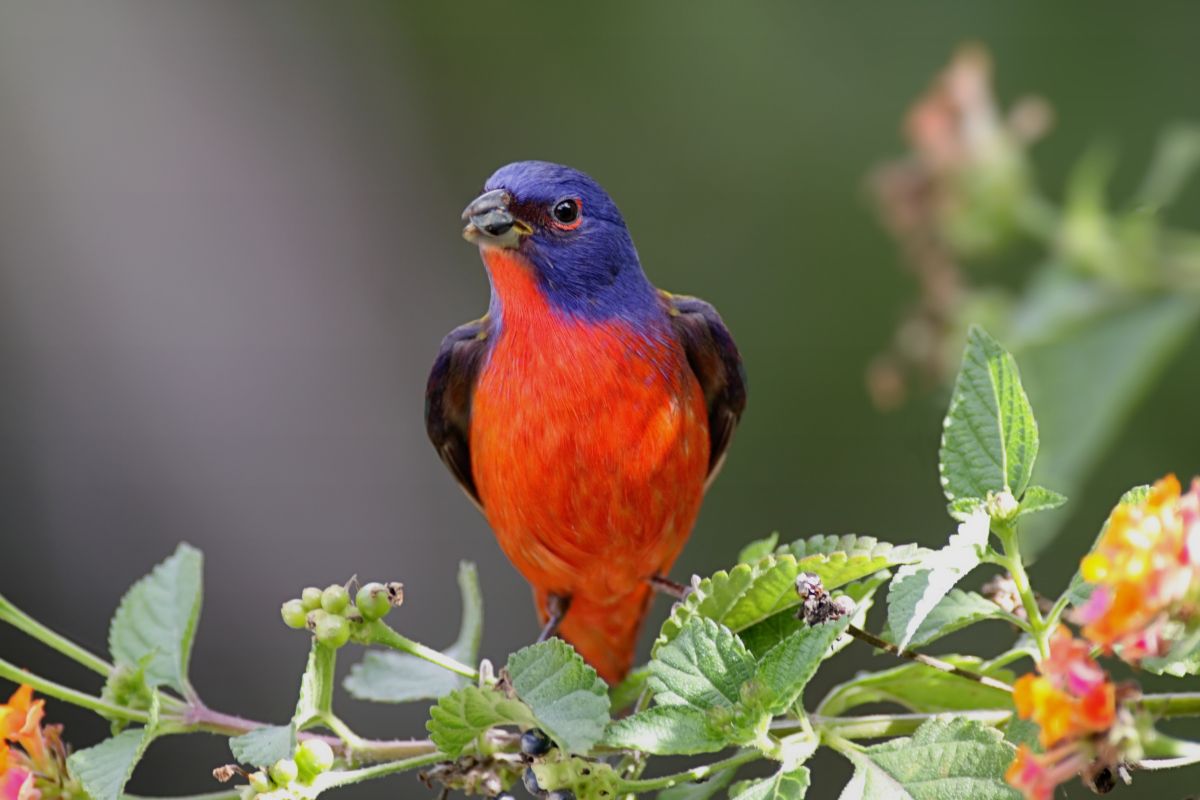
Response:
[1074,475,1200,664]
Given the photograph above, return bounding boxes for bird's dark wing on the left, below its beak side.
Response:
[425,317,491,510]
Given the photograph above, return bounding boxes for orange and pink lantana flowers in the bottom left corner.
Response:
[0,686,77,800]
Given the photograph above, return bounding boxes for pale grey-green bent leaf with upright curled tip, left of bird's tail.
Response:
[342,561,484,703]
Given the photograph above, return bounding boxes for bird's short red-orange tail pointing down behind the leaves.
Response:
[535,583,654,686]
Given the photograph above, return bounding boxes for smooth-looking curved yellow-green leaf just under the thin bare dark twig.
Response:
[817,656,1016,716]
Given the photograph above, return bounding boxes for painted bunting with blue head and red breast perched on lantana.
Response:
[425,161,746,685]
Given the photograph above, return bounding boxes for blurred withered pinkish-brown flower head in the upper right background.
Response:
[868,46,1050,408]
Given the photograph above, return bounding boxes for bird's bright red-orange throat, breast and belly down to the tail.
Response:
[470,248,709,680]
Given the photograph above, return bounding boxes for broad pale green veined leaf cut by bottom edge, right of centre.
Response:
[840,718,1021,800]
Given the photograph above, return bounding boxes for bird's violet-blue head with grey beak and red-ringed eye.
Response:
[462,161,656,321]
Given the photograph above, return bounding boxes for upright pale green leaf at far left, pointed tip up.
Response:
[108,545,204,694]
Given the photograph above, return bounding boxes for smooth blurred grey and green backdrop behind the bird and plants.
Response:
[0,0,1200,799]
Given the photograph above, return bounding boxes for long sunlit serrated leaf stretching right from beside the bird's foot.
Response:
[654,536,926,654]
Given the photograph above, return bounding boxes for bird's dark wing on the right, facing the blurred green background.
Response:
[660,290,746,488]
